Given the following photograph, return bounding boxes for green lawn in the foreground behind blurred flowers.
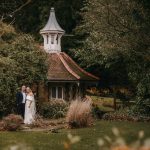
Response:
[0,121,150,150]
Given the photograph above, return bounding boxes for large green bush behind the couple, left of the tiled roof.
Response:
[0,22,47,115]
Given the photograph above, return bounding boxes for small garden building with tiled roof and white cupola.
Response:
[39,8,99,101]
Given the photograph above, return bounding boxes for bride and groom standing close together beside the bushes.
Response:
[16,85,36,124]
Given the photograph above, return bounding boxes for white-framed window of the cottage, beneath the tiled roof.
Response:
[51,87,63,99]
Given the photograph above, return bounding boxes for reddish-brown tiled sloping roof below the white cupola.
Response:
[47,52,99,82]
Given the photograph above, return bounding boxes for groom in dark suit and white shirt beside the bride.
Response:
[16,85,26,119]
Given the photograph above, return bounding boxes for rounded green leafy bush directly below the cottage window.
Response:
[40,100,68,119]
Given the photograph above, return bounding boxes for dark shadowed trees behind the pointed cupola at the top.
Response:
[0,0,83,50]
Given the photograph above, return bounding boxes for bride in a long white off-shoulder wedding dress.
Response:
[24,87,36,124]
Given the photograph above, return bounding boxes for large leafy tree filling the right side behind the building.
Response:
[73,0,150,113]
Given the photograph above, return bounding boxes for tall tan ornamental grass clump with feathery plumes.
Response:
[66,100,92,128]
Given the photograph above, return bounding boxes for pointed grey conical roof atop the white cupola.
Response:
[40,8,65,33]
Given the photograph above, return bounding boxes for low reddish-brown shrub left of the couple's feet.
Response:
[3,114,23,131]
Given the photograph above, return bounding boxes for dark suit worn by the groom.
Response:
[16,92,25,118]
